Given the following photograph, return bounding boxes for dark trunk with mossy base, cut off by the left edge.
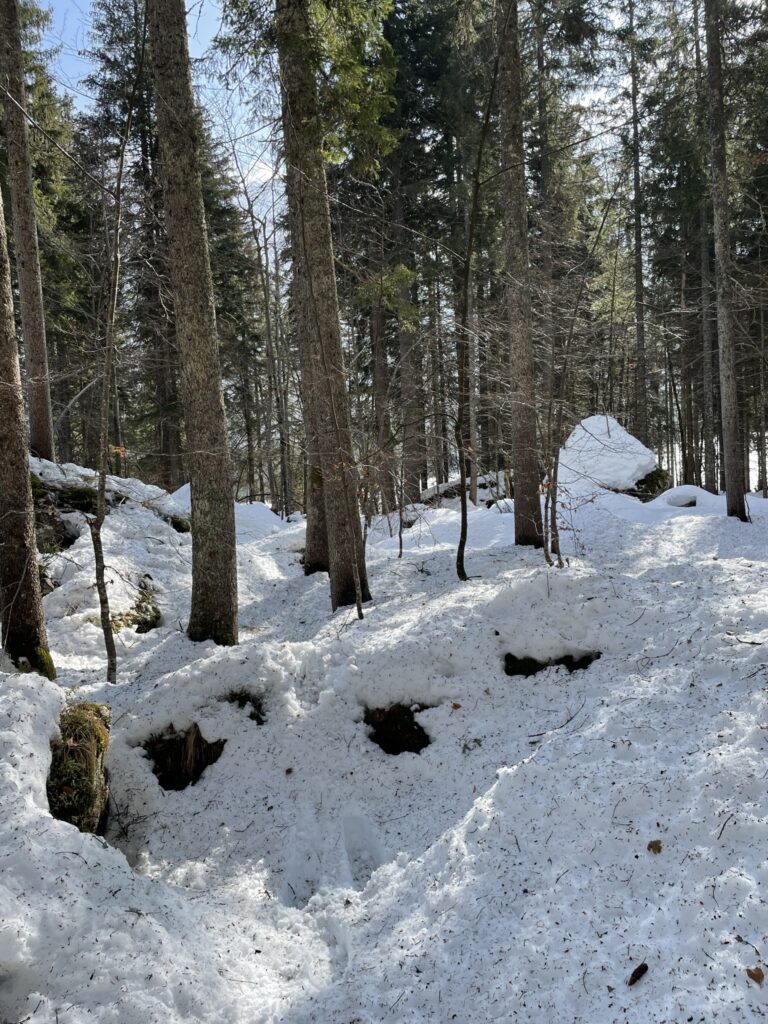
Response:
[0,177,56,679]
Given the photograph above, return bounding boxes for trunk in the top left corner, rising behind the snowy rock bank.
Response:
[0,0,55,462]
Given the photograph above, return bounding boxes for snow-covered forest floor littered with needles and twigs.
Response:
[0,444,768,1024]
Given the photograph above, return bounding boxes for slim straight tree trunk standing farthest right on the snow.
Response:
[705,0,748,522]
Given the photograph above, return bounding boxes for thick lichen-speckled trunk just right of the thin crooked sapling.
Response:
[147,0,238,644]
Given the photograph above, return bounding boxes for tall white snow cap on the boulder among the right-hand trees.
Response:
[558,416,657,490]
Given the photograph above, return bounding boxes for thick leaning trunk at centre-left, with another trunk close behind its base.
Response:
[275,0,370,614]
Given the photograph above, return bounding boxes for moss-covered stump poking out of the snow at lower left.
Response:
[48,703,112,835]
